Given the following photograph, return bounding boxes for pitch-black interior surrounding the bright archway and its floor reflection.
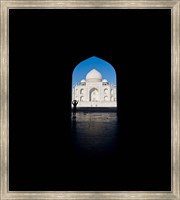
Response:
[9,9,171,191]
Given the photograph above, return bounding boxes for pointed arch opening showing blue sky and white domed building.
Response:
[72,56,117,108]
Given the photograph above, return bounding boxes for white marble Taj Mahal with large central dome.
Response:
[72,69,117,107]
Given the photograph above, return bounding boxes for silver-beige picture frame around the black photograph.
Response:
[0,0,180,200]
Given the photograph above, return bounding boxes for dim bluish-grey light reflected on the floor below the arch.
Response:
[71,112,118,157]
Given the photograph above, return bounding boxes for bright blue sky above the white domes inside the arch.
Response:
[72,56,116,85]
